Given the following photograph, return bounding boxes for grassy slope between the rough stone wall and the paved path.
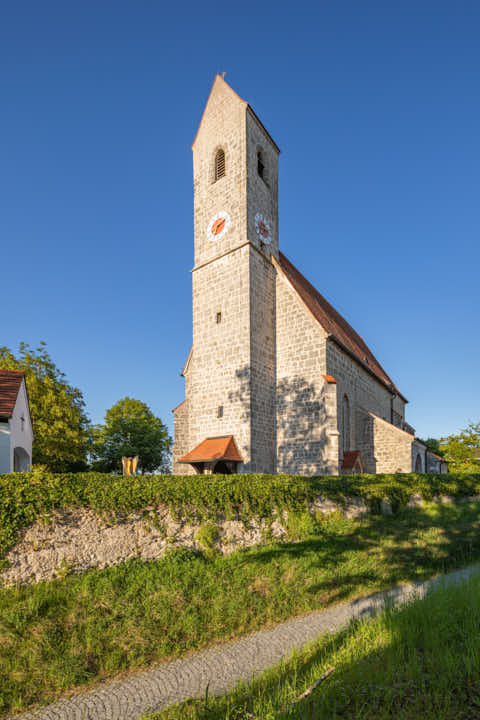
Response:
[0,503,480,717]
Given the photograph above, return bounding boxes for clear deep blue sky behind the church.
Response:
[0,0,480,436]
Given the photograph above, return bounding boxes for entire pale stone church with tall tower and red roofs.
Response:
[173,75,442,475]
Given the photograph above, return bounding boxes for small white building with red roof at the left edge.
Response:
[0,370,33,474]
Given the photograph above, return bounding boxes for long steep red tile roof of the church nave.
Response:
[279,253,406,400]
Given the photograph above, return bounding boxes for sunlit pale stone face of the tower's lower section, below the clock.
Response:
[188,246,251,471]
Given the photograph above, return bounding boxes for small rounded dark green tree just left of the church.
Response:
[92,397,172,473]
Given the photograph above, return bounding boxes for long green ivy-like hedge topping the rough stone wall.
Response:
[0,469,480,557]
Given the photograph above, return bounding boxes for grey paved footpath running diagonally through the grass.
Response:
[15,565,480,720]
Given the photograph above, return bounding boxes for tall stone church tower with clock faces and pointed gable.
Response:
[174,75,279,473]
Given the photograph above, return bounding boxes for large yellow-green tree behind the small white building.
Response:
[0,342,89,472]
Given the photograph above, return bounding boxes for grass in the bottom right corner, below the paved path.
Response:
[145,574,480,720]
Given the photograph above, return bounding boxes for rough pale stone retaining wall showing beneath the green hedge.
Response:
[0,495,472,586]
